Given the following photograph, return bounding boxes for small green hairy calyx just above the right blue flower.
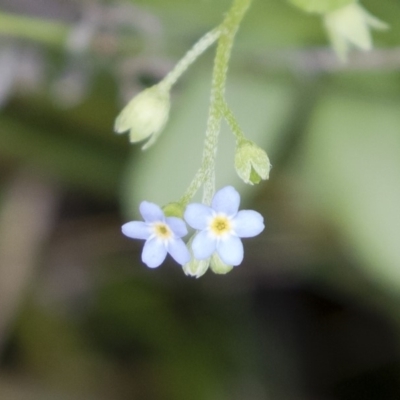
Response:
[235,140,271,185]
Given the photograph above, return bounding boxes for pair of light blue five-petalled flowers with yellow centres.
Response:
[122,186,264,268]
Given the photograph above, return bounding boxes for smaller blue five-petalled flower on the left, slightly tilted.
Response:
[122,201,190,268]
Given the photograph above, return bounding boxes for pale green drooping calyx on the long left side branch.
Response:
[114,84,170,150]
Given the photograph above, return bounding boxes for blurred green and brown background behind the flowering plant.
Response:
[0,0,400,400]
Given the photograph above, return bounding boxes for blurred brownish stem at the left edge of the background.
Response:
[0,169,59,353]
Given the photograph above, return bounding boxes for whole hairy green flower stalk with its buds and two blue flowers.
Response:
[119,0,270,278]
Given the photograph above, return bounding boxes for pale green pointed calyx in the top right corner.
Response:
[324,2,388,61]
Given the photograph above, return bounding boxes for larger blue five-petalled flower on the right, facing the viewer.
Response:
[184,186,264,265]
